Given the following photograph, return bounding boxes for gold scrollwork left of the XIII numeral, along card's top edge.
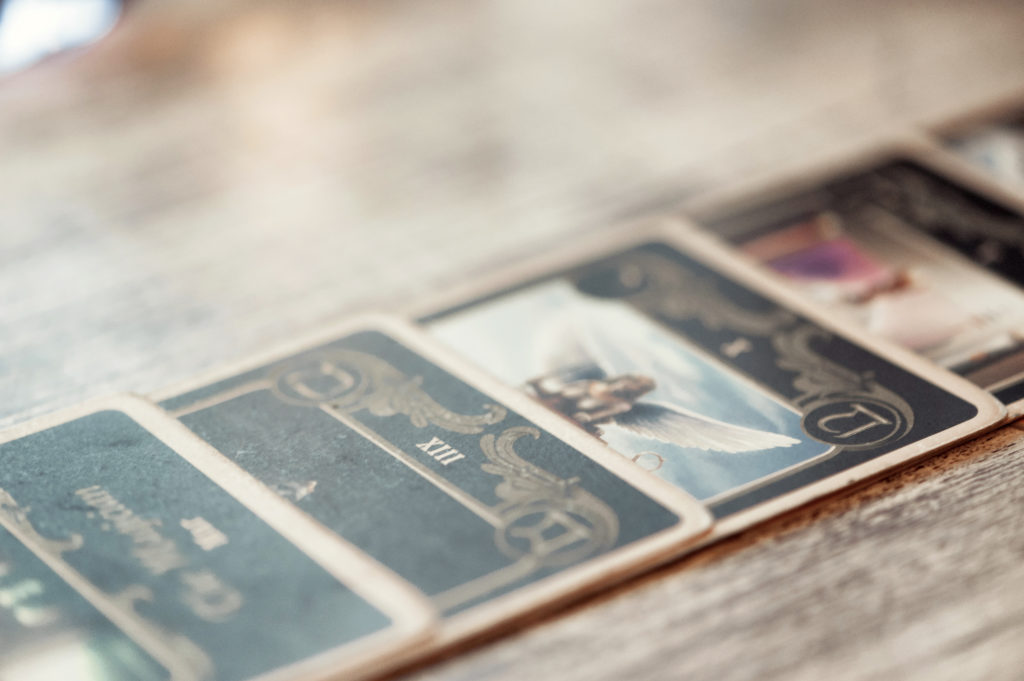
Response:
[271,349,507,434]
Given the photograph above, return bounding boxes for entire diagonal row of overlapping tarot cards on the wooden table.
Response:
[6,96,1024,681]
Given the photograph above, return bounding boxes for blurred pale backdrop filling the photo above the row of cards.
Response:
[0,0,1024,425]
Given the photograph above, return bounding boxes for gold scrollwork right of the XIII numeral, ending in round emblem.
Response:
[480,426,618,567]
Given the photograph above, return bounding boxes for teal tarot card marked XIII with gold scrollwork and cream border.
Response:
[153,317,711,642]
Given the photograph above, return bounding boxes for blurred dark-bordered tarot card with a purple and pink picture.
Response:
[698,143,1024,416]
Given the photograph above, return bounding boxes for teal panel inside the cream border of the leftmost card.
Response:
[0,411,390,680]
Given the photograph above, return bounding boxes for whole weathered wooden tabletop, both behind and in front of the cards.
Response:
[0,0,1024,681]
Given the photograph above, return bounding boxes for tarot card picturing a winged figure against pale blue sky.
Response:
[411,218,1002,536]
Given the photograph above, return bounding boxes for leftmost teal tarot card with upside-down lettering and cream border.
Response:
[0,397,432,681]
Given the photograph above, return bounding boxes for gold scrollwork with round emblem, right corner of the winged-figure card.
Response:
[773,325,914,450]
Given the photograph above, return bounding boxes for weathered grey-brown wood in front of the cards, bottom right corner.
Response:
[397,428,1024,681]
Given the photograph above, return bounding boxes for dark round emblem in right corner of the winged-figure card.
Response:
[802,397,908,450]
